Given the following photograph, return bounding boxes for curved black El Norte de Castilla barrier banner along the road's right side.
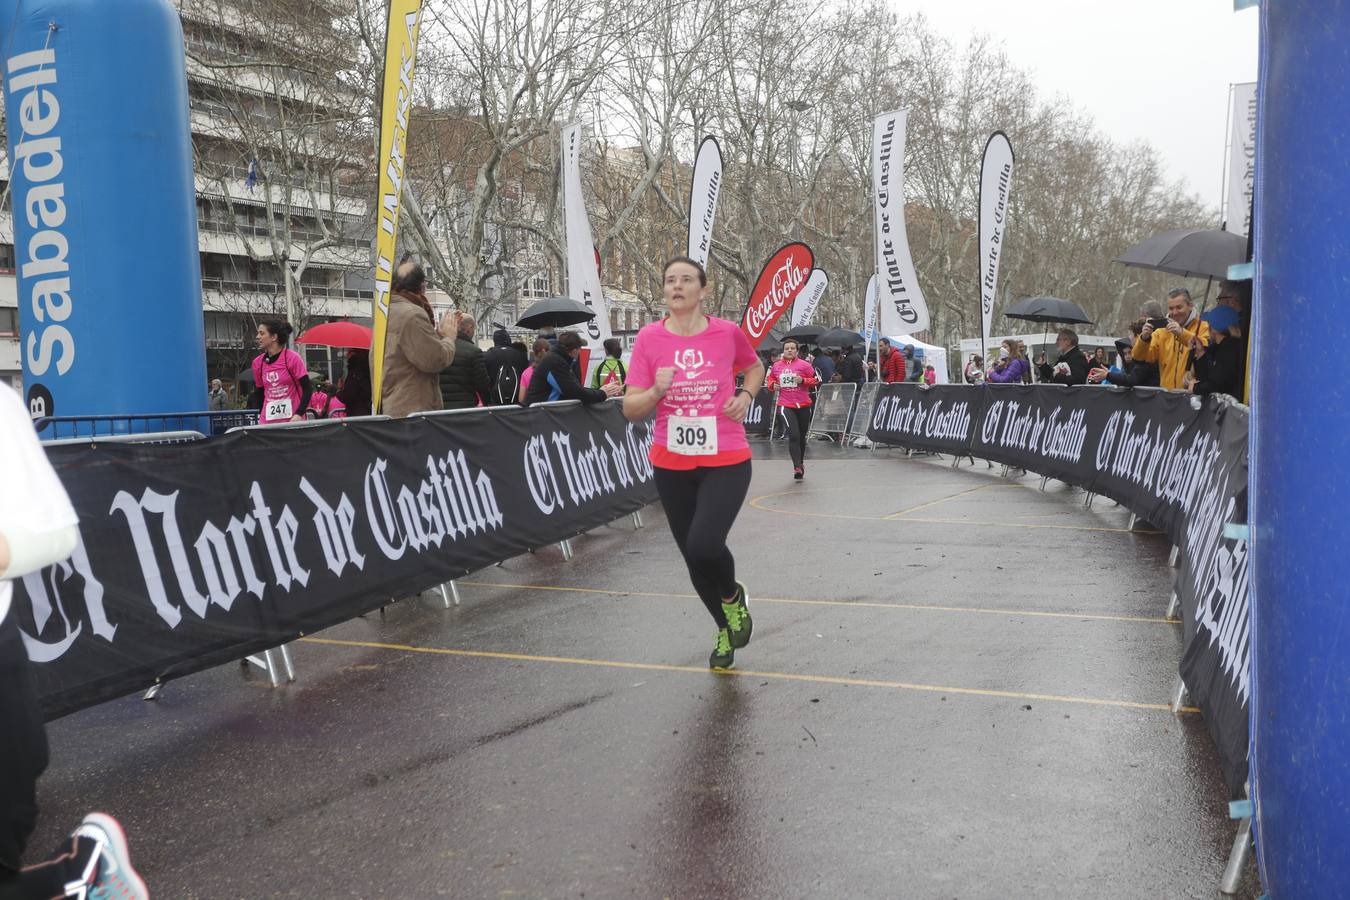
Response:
[868,383,1251,796]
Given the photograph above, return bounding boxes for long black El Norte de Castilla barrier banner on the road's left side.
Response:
[12,403,656,716]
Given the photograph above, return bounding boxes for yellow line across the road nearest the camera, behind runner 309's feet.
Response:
[300,637,1200,714]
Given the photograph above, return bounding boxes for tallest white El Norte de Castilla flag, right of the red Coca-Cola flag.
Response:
[872,109,929,335]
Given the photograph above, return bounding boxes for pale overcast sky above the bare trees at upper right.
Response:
[891,0,1258,209]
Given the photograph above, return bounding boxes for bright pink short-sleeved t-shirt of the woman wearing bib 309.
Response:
[628,316,759,470]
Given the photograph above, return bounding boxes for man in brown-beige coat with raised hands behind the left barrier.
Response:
[379,259,463,417]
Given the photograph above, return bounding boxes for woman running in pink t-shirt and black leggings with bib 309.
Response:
[624,256,764,669]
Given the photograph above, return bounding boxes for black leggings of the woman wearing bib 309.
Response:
[656,460,751,629]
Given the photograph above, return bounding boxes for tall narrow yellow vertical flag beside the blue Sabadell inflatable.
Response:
[370,0,421,413]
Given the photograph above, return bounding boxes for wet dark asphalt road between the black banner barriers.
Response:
[34,445,1257,897]
